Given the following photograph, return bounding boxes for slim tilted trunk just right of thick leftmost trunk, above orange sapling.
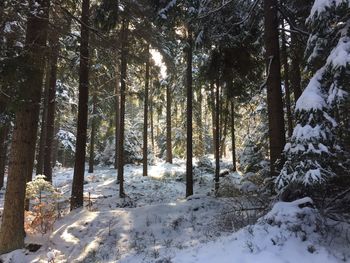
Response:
[36,66,50,174]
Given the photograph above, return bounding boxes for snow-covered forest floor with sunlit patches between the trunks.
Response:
[0,161,350,263]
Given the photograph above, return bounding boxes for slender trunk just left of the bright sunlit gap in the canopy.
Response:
[143,44,150,176]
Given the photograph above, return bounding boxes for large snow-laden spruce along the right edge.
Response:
[276,1,350,199]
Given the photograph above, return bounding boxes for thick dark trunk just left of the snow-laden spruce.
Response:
[264,0,286,175]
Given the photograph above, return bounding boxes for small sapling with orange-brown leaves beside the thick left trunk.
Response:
[25,175,60,234]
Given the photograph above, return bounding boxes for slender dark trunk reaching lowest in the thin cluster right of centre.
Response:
[215,78,220,192]
